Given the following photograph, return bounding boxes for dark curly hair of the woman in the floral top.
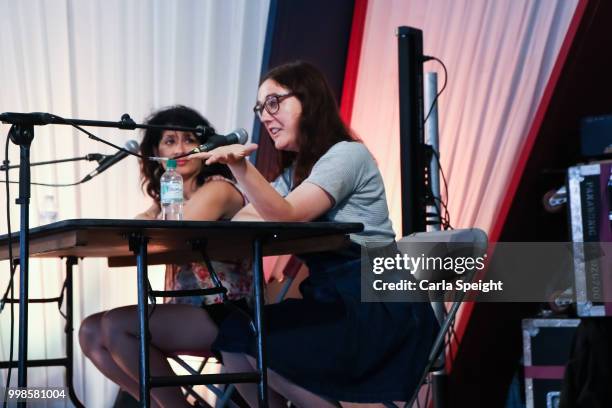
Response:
[140,105,232,201]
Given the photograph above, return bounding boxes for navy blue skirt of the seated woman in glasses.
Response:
[213,245,438,403]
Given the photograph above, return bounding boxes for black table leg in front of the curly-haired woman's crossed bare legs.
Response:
[130,234,151,408]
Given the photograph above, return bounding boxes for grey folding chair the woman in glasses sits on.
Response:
[399,228,488,408]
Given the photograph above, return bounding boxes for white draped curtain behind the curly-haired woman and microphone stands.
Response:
[0,0,269,407]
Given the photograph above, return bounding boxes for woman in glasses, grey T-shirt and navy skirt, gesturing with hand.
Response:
[191,62,437,407]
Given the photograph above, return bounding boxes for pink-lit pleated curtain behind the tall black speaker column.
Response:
[351,0,578,237]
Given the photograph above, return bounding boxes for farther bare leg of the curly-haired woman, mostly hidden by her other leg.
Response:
[79,312,138,398]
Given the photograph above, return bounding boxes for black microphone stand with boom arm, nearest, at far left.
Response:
[0,112,211,398]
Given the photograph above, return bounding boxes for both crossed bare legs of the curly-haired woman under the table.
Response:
[79,305,218,407]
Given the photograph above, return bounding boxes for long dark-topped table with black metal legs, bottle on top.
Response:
[0,219,363,407]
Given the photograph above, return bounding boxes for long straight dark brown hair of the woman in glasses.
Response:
[260,61,357,188]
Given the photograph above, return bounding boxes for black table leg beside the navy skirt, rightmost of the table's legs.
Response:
[253,238,268,407]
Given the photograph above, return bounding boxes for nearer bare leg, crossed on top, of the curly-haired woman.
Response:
[101,305,217,407]
